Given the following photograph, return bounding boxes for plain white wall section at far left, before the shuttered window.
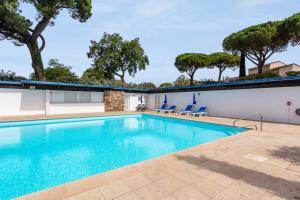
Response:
[0,88,46,116]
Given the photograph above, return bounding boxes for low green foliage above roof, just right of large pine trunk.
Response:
[31,59,79,83]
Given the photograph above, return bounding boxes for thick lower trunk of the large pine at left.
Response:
[27,41,46,81]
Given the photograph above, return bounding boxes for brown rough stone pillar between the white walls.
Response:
[104,90,125,112]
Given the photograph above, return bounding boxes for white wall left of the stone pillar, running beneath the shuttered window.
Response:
[0,88,105,116]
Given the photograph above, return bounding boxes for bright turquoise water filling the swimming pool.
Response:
[0,114,245,199]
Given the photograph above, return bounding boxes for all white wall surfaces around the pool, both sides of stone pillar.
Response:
[0,87,300,124]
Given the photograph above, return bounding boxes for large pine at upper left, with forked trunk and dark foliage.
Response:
[0,0,92,80]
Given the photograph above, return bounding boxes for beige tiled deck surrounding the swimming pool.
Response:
[0,113,300,200]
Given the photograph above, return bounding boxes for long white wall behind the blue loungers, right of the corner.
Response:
[148,87,300,124]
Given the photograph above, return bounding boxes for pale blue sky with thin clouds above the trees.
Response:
[0,0,300,84]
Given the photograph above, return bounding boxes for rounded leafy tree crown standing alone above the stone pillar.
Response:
[87,33,149,82]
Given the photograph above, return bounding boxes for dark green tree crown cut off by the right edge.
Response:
[278,13,300,46]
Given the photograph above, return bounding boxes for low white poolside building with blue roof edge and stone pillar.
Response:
[0,77,300,124]
